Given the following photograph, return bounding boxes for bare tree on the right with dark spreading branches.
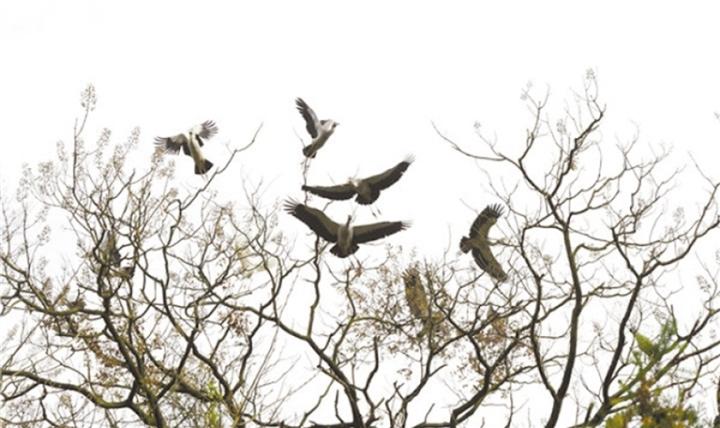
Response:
[436,72,719,427]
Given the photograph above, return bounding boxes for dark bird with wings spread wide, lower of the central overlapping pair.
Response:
[285,200,410,258]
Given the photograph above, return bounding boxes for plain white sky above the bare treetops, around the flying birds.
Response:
[0,0,720,424]
